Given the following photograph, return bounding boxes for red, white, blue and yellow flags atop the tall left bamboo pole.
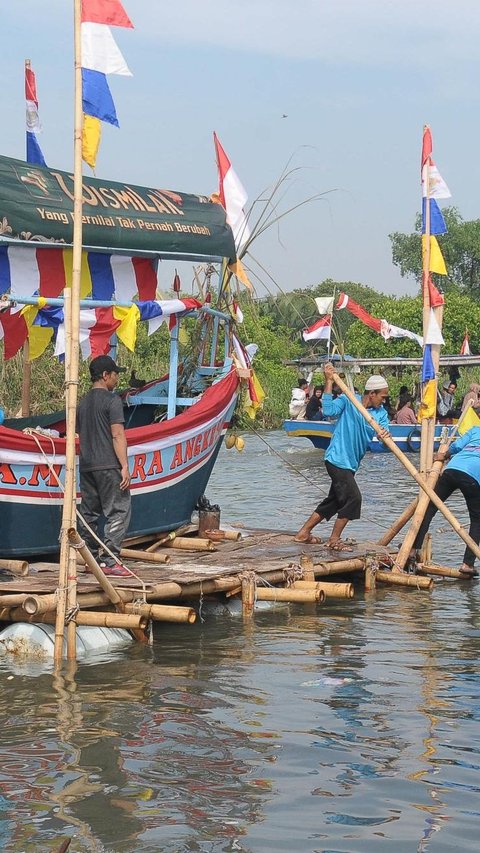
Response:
[81,0,133,169]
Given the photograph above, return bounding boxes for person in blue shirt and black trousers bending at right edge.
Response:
[412,427,480,575]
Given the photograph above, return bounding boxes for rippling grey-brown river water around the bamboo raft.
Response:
[0,433,480,853]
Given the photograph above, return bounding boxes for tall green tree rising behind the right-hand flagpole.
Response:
[389,207,480,301]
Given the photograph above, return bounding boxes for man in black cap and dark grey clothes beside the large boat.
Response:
[77,355,131,577]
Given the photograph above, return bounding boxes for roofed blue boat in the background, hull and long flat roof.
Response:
[283,355,480,453]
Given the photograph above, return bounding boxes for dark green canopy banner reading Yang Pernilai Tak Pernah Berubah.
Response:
[0,157,236,260]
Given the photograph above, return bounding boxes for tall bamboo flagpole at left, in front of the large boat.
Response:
[54,0,83,666]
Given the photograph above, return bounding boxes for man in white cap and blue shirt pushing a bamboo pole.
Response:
[295,364,389,551]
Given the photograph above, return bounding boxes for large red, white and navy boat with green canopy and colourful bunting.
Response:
[0,157,244,557]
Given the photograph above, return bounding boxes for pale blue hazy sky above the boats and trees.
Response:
[0,0,480,302]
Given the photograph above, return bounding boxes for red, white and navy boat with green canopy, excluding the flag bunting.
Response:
[0,157,239,557]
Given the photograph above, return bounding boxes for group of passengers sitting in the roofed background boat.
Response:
[288,375,480,426]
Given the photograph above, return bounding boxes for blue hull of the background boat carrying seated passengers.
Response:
[283,420,444,453]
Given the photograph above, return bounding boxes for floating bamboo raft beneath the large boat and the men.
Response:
[0,529,472,642]
